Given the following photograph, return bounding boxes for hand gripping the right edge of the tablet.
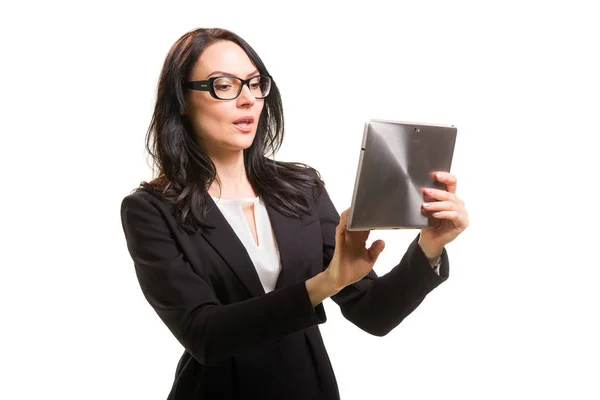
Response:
[419,172,469,262]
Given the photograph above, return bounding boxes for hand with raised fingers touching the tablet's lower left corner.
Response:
[306,209,385,306]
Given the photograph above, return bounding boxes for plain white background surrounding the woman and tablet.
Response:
[0,0,600,400]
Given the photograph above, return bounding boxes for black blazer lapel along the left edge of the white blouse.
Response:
[202,197,265,297]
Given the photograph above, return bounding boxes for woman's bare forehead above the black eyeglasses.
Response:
[192,40,256,79]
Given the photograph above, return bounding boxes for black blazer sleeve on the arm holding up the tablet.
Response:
[316,186,449,336]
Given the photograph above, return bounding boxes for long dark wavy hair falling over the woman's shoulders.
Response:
[137,28,323,233]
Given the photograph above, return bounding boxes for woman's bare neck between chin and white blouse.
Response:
[208,151,256,199]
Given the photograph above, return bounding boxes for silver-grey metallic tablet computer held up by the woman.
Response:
[348,119,457,231]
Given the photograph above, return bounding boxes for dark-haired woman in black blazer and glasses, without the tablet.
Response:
[121,29,468,400]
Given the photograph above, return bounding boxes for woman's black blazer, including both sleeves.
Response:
[121,185,449,400]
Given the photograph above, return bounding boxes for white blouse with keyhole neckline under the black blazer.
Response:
[211,196,281,293]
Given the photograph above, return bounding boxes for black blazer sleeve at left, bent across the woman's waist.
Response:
[121,192,325,364]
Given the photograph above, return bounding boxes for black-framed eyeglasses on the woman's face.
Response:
[185,75,271,100]
